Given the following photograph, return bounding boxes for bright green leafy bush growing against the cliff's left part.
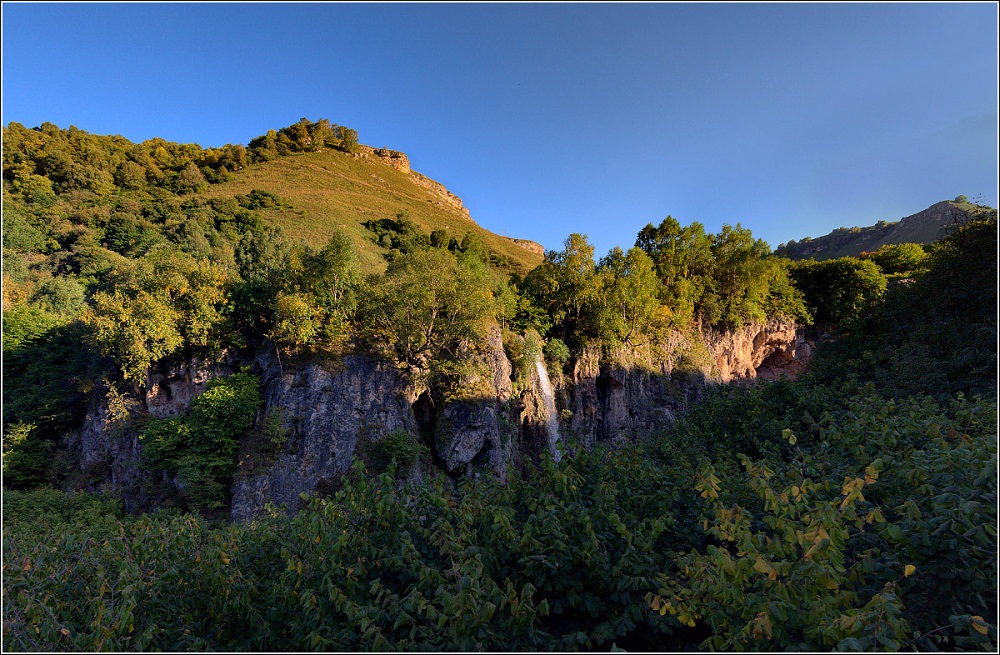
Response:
[139,373,263,511]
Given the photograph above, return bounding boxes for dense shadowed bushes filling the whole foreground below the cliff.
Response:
[4,385,997,650]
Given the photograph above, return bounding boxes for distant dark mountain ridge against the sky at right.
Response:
[775,196,984,260]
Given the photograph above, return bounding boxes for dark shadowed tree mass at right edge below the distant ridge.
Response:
[809,215,997,399]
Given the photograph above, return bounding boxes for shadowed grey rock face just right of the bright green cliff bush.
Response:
[231,355,417,521]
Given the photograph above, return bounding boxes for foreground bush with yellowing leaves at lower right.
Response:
[648,459,910,651]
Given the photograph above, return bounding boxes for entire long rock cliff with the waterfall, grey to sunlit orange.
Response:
[71,321,812,521]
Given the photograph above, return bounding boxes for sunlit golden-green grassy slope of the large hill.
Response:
[204,148,542,275]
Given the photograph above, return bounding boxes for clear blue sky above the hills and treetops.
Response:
[2,2,998,256]
